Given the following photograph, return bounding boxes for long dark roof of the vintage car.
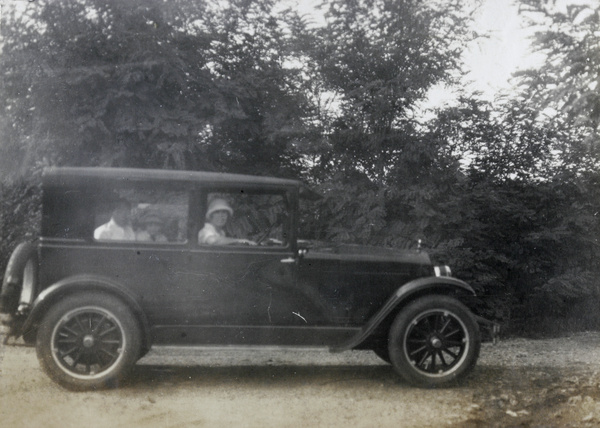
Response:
[42,167,318,199]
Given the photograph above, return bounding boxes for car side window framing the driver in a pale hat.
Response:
[198,190,289,246]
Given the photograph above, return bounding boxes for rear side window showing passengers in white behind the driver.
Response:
[94,189,189,244]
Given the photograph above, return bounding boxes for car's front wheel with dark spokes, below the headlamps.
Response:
[389,295,481,387]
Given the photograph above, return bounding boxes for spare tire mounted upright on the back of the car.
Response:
[0,242,38,314]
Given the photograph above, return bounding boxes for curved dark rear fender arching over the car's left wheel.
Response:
[22,275,152,350]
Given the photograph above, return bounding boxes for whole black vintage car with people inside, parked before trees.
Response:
[0,168,496,390]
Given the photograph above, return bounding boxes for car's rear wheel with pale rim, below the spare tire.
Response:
[36,292,141,391]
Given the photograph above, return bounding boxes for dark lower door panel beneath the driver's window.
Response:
[180,244,296,327]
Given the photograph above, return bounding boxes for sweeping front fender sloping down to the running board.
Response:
[331,276,475,352]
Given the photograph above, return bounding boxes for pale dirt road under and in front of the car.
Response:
[0,333,600,428]
